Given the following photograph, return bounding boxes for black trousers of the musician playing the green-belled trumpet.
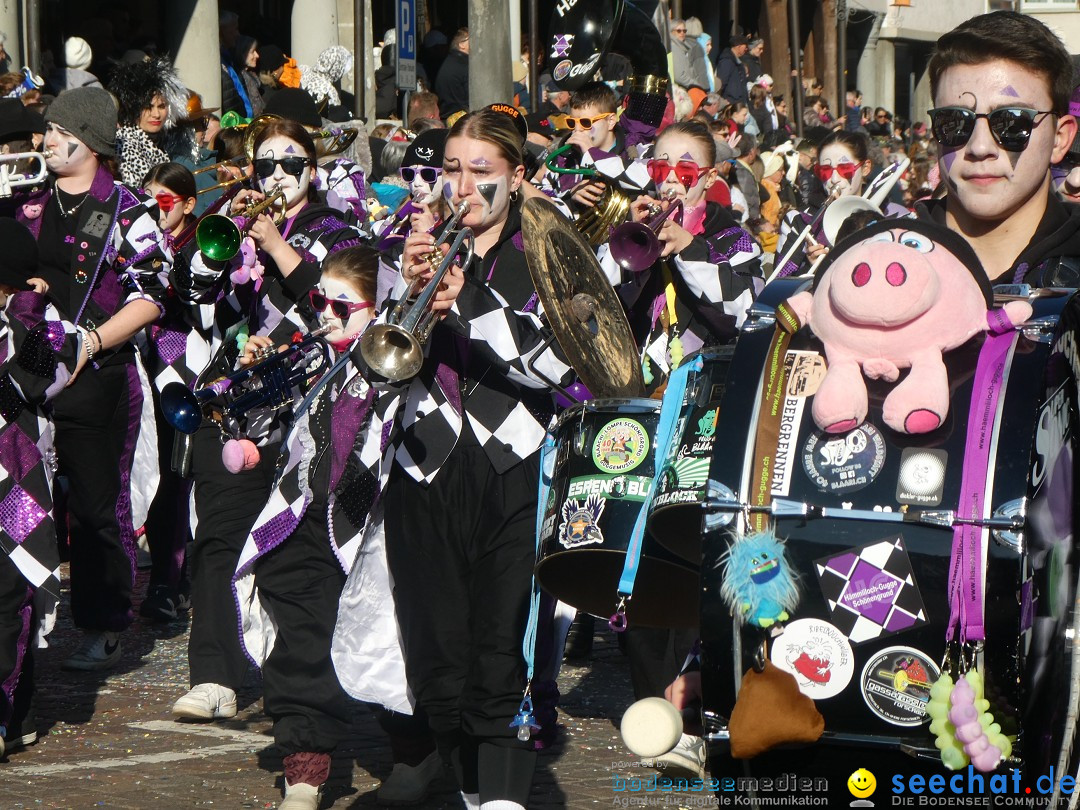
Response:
[188,426,278,689]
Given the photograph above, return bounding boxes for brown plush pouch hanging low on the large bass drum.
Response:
[728,660,825,759]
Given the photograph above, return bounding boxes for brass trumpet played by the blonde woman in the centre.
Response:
[360,200,475,382]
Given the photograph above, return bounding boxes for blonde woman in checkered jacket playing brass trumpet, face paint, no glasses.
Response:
[383,109,571,810]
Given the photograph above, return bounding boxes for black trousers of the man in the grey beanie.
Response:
[53,363,137,631]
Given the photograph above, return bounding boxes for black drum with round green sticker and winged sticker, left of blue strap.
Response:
[536,399,700,627]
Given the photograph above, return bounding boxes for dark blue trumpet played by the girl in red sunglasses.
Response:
[161,325,332,438]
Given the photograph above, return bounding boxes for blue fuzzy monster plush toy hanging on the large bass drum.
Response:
[720,531,799,627]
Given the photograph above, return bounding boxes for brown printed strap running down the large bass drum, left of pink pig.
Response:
[748,303,801,532]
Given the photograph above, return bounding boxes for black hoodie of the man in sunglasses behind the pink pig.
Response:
[915,192,1080,287]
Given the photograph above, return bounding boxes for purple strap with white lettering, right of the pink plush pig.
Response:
[946,319,1018,644]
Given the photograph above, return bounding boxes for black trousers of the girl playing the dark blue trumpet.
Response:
[255,507,353,754]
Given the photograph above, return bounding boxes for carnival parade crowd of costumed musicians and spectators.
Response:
[0,6,1080,810]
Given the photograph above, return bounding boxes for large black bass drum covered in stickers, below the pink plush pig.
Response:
[701,280,1080,806]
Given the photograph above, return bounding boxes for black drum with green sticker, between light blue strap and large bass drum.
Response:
[649,346,734,566]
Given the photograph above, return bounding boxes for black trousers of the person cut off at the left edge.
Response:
[0,553,37,733]
